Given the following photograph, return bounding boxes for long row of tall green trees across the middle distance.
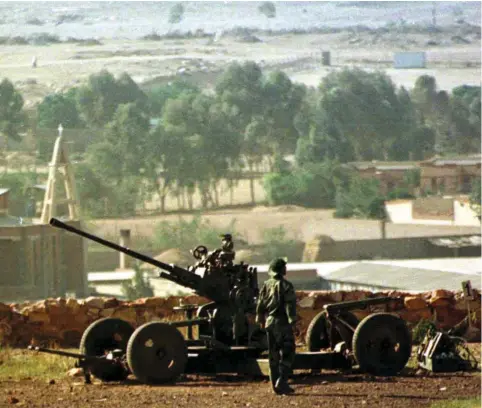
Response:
[0,62,481,215]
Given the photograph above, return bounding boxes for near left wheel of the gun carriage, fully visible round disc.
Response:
[127,322,187,384]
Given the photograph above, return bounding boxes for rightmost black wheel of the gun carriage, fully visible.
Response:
[353,313,412,376]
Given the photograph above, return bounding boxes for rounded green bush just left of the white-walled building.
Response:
[335,176,385,219]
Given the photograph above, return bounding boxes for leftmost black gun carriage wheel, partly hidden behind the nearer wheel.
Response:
[79,317,134,381]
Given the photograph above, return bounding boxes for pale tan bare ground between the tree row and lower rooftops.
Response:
[91,206,480,244]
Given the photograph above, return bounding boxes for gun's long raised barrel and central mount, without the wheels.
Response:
[50,218,260,346]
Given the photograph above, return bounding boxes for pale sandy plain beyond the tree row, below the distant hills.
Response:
[0,27,480,107]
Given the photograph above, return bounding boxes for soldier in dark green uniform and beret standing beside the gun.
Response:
[256,258,296,394]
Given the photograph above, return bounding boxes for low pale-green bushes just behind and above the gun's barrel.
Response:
[153,214,242,251]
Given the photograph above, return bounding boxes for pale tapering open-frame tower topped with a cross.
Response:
[40,125,80,224]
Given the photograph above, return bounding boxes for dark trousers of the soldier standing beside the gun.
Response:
[266,323,296,382]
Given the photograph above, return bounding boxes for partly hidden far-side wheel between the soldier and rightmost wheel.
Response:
[305,311,359,351]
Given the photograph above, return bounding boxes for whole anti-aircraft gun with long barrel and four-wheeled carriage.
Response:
[29,218,412,384]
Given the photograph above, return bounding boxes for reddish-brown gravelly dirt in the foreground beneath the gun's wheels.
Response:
[0,372,480,408]
